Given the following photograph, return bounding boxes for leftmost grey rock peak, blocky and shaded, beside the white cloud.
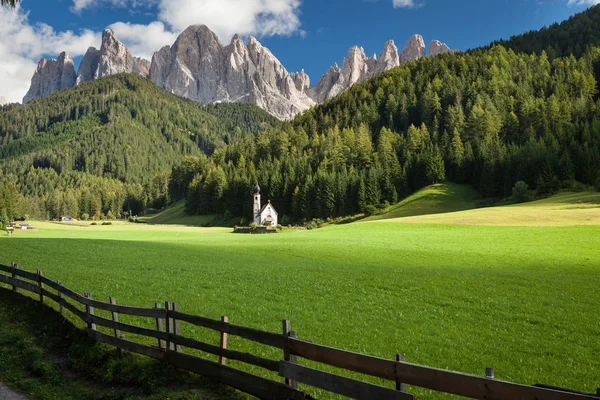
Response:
[23,52,76,104]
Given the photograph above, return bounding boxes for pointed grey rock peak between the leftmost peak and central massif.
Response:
[77,29,150,85]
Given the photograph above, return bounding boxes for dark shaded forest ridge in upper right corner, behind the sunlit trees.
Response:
[492,5,600,61]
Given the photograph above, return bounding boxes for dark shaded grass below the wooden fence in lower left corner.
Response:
[0,288,243,400]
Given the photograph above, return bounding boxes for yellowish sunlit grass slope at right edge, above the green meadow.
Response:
[388,192,600,226]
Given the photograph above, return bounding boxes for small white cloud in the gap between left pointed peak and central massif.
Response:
[110,21,177,60]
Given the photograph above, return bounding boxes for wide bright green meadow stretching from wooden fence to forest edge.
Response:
[0,193,600,399]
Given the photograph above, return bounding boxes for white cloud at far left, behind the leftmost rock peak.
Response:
[0,7,100,102]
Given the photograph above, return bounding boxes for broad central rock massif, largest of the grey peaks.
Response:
[150,25,314,119]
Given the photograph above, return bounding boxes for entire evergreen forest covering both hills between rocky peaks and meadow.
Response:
[0,6,600,224]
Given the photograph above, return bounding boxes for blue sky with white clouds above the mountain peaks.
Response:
[0,0,600,101]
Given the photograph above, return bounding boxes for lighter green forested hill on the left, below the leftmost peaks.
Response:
[0,74,278,218]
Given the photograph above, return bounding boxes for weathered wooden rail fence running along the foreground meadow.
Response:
[0,264,600,400]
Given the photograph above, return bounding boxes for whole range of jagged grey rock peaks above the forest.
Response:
[23,25,456,119]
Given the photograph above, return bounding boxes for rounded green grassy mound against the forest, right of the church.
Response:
[366,183,480,221]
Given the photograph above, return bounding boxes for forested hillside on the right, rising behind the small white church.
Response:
[174,46,600,223]
